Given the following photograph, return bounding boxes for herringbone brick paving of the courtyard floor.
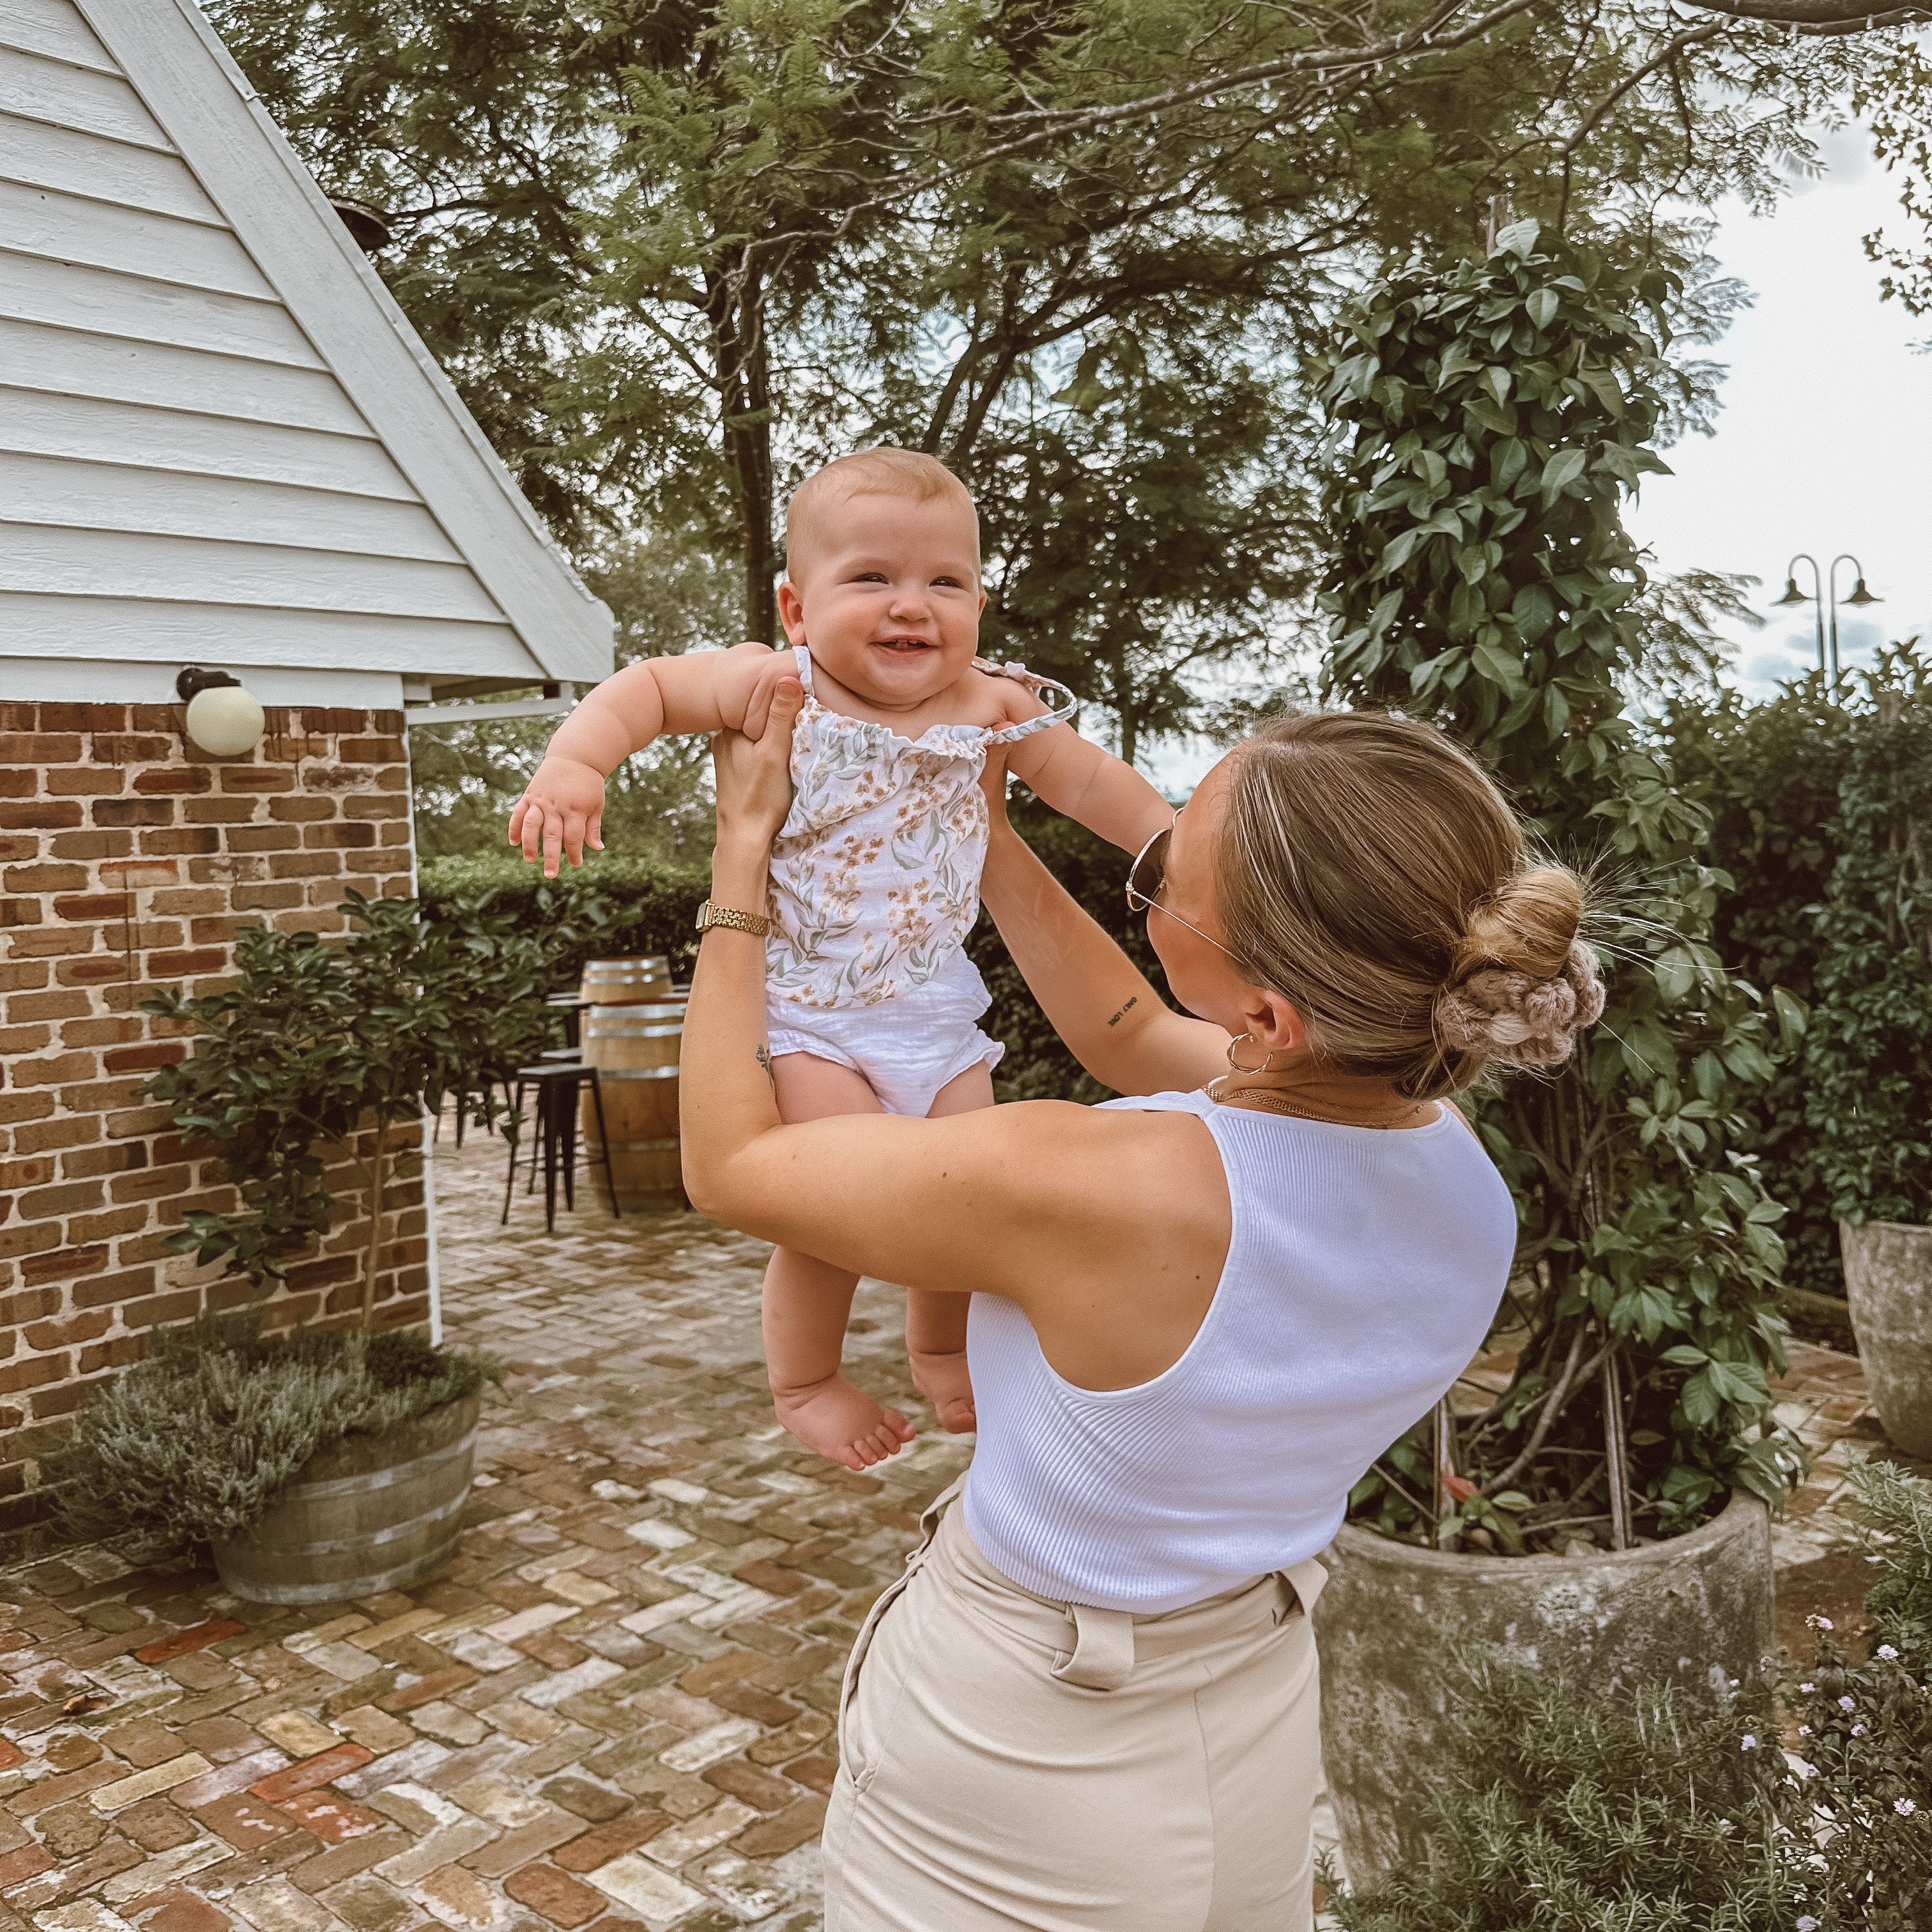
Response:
[0,1138,1901,1932]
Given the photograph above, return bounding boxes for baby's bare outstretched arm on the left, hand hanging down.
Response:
[510,643,792,879]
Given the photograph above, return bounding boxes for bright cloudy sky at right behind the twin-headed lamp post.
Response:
[1627,128,1932,698]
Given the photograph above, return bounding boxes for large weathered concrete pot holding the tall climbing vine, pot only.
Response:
[1315,1490,1772,1880]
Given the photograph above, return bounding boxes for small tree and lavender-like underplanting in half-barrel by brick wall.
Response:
[52,893,529,1604]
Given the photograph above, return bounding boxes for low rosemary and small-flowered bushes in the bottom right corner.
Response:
[1323,1462,1932,1932]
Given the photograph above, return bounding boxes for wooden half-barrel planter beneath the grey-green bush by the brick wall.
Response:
[215,1395,483,1604]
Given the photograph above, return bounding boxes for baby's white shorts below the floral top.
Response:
[765,953,1007,1119]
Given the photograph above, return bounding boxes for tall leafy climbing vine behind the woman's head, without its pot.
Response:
[1321,222,1802,1549]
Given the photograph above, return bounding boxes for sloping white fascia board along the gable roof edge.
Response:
[75,0,615,684]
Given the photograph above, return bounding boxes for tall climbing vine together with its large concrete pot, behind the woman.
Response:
[1315,222,1804,1876]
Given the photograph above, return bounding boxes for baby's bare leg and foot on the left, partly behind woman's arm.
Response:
[765,1053,912,1468]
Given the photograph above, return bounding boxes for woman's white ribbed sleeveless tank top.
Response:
[966,1094,1517,1613]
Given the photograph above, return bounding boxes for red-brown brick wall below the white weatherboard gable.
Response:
[0,703,429,1557]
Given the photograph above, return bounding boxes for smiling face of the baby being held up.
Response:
[779,491,985,711]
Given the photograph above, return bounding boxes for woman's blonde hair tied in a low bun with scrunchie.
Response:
[1219,711,1604,1100]
